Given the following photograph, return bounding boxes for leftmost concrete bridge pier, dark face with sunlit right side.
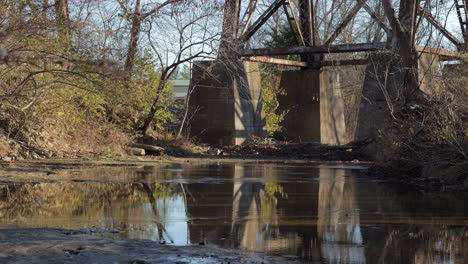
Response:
[189,60,266,147]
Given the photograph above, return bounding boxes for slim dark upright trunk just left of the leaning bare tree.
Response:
[124,0,142,80]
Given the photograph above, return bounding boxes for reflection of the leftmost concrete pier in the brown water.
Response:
[187,164,313,253]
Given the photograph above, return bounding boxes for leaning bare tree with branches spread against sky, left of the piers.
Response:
[141,1,220,134]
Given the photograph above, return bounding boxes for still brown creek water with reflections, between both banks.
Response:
[0,163,468,263]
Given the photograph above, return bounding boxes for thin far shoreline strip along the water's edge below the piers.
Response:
[0,155,468,195]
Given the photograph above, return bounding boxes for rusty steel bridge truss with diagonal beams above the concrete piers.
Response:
[240,0,468,63]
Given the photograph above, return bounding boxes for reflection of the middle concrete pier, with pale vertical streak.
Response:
[270,168,370,263]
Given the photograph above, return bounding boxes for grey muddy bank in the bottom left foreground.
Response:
[0,229,298,264]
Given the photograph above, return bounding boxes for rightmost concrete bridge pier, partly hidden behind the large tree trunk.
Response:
[354,53,443,140]
